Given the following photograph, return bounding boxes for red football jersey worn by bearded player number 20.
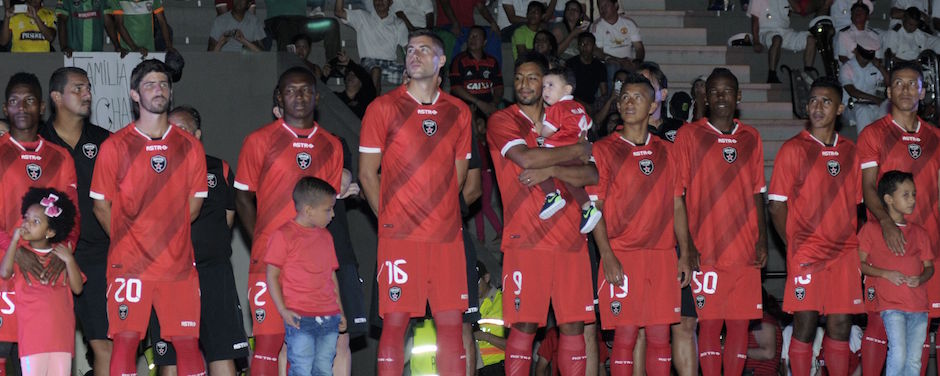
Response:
[89,123,209,281]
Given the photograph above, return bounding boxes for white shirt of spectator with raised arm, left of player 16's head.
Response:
[343,9,408,61]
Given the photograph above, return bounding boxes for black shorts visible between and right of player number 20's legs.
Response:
[150,262,248,366]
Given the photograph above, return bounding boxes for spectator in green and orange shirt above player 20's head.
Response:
[109,0,176,56]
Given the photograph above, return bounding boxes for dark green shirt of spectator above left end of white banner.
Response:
[55,0,111,51]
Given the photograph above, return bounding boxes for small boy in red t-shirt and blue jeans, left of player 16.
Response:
[264,177,346,375]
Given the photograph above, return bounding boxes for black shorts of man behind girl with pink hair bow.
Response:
[74,260,108,341]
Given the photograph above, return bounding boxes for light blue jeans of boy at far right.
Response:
[881,310,927,376]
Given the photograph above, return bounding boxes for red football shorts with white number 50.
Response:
[691,265,763,320]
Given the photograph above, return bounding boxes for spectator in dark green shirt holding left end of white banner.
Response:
[55,0,126,57]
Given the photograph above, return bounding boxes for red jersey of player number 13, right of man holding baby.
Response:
[587,133,682,251]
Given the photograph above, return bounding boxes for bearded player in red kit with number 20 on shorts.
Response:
[89,60,208,375]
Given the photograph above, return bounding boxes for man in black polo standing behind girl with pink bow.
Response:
[39,67,111,376]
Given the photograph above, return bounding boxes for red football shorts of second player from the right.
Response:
[783,249,865,315]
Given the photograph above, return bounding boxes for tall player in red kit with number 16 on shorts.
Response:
[360,29,471,375]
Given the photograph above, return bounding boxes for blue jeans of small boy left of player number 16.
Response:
[284,315,339,376]
